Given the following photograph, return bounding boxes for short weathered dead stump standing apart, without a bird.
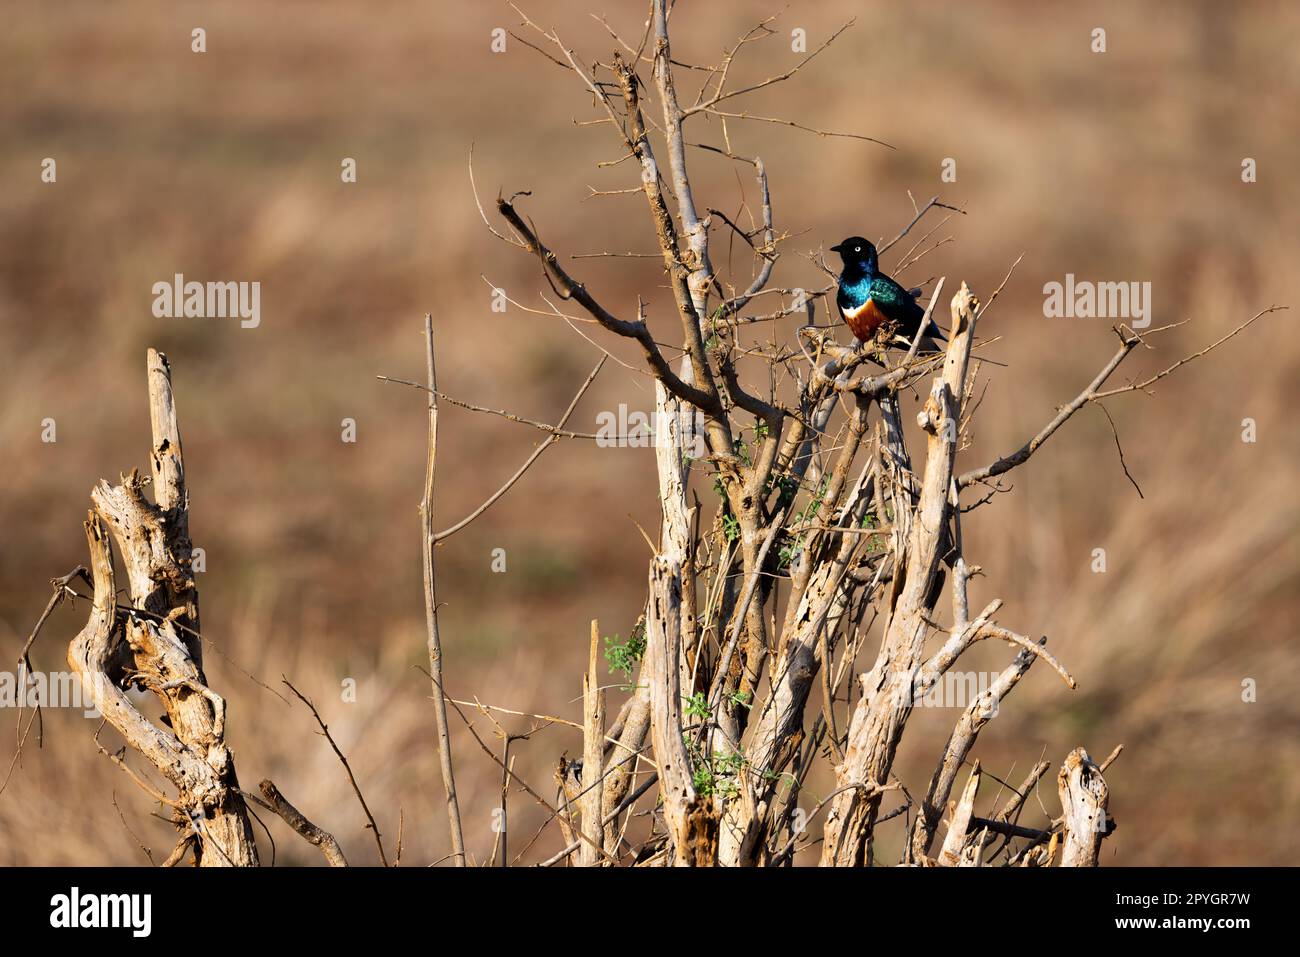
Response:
[68,348,257,867]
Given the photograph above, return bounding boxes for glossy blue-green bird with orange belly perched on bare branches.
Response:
[831,235,948,352]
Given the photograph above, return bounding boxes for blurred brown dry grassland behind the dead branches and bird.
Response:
[0,0,1300,865]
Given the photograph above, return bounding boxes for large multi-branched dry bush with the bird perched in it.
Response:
[458,0,1273,866]
